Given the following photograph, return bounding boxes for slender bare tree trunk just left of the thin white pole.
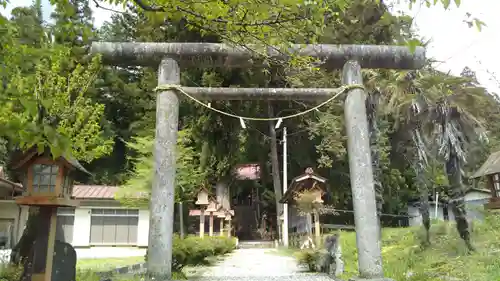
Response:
[267,102,283,241]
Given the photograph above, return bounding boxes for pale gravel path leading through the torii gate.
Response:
[200,249,333,281]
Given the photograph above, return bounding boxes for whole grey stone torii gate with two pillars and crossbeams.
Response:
[91,42,425,280]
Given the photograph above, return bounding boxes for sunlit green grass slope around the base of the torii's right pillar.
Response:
[341,212,500,281]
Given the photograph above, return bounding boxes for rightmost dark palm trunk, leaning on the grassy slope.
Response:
[446,143,474,251]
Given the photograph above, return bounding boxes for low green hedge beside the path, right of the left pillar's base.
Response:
[146,235,236,272]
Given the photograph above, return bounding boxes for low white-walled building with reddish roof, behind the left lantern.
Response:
[0,182,149,258]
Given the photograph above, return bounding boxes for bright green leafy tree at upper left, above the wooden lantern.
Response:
[0,2,113,162]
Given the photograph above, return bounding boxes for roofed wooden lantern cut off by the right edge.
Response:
[471,151,500,210]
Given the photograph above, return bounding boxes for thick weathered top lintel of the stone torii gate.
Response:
[90,42,425,69]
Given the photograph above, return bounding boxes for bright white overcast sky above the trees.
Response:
[0,0,500,93]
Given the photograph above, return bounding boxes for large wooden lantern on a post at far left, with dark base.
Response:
[12,148,89,281]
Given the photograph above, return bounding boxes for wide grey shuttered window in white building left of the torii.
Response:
[90,209,139,245]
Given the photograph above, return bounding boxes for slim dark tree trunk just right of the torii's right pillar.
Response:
[366,92,384,235]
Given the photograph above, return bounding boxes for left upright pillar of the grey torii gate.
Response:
[147,57,180,280]
